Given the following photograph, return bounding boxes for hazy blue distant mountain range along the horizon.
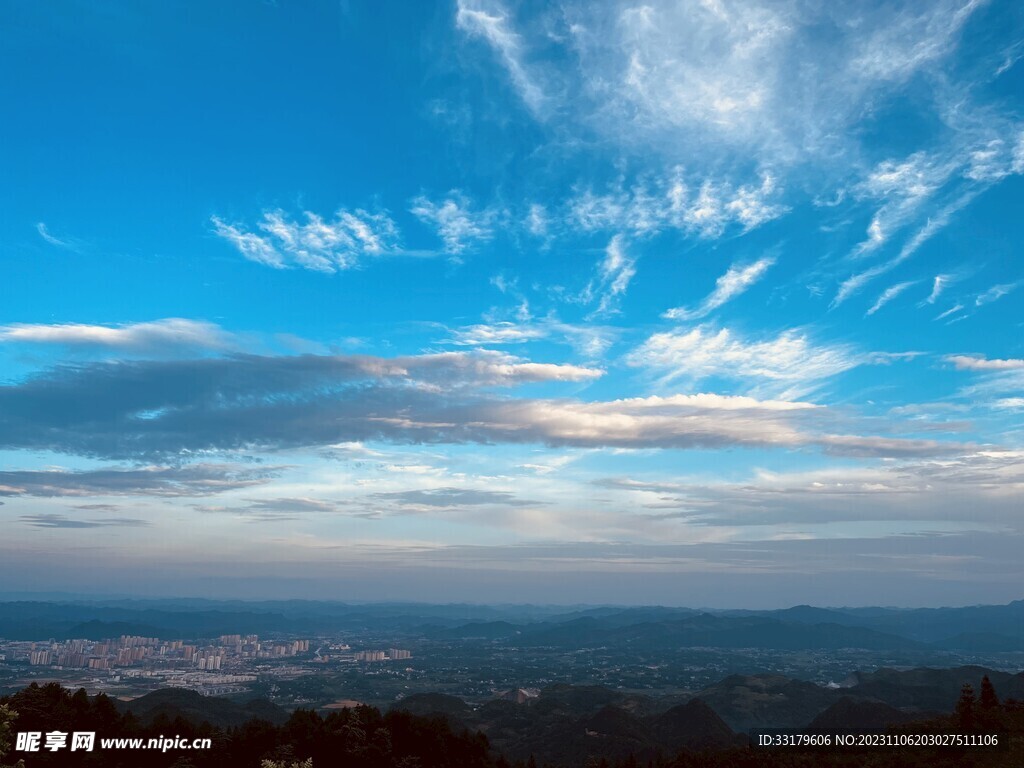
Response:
[0,600,1024,652]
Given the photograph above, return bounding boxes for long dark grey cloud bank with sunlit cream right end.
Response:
[0,350,963,460]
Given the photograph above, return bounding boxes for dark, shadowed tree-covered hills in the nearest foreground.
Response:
[0,683,1024,768]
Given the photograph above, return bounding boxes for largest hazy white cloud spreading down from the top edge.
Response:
[456,0,979,167]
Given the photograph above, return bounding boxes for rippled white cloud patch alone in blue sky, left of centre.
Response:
[211,209,398,272]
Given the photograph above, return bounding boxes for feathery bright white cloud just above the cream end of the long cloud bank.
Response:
[626,325,864,397]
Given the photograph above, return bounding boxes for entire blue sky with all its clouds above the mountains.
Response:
[0,0,1024,606]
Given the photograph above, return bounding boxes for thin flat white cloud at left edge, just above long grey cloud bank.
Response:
[0,317,238,352]
